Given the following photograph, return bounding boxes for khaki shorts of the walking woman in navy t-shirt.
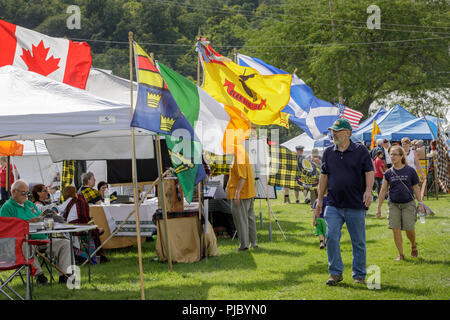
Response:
[388,200,417,231]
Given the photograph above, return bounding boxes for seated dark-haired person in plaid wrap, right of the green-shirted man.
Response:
[59,186,109,263]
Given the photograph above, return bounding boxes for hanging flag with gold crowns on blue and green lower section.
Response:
[131,43,206,203]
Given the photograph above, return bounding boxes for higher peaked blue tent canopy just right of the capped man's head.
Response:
[352,104,417,142]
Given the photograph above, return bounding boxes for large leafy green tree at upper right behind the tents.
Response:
[242,0,450,119]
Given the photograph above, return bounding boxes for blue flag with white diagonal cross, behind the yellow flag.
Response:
[238,54,340,139]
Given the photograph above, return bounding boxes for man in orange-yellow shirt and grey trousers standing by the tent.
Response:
[227,147,258,251]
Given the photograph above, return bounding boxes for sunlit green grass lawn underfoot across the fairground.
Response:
[0,192,450,300]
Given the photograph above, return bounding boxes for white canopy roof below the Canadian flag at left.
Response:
[0,66,135,140]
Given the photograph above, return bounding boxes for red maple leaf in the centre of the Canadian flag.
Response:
[20,40,61,76]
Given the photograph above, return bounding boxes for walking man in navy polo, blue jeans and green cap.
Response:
[314,118,374,285]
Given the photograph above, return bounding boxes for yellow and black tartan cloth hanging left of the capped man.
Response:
[269,146,303,190]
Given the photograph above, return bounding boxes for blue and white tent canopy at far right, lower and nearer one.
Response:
[375,116,438,141]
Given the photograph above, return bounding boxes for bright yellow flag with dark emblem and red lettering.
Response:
[197,38,292,128]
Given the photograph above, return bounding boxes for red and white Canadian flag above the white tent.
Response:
[0,20,92,89]
